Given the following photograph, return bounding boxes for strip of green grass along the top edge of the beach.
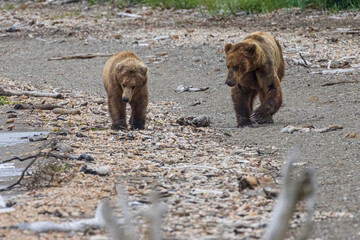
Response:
[114,0,360,16]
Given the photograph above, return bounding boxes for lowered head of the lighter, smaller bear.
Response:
[116,59,148,102]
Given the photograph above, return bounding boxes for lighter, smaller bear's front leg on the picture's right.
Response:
[130,98,147,130]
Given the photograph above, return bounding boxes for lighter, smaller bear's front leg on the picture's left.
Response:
[108,95,127,130]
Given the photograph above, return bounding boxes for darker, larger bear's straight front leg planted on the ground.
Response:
[231,84,257,127]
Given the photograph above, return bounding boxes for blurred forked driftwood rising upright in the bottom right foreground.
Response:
[263,151,316,240]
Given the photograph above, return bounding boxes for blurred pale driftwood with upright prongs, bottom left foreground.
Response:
[16,185,165,240]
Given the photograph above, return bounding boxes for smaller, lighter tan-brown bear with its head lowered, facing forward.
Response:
[103,51,148,130]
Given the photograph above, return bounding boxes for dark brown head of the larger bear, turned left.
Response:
[225,42,261,87]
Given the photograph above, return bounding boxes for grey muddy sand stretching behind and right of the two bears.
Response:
[0,0,360,239]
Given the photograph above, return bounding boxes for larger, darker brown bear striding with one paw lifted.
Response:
[225,32,285,127]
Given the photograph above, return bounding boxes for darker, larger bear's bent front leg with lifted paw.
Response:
[250,78,282,124]
